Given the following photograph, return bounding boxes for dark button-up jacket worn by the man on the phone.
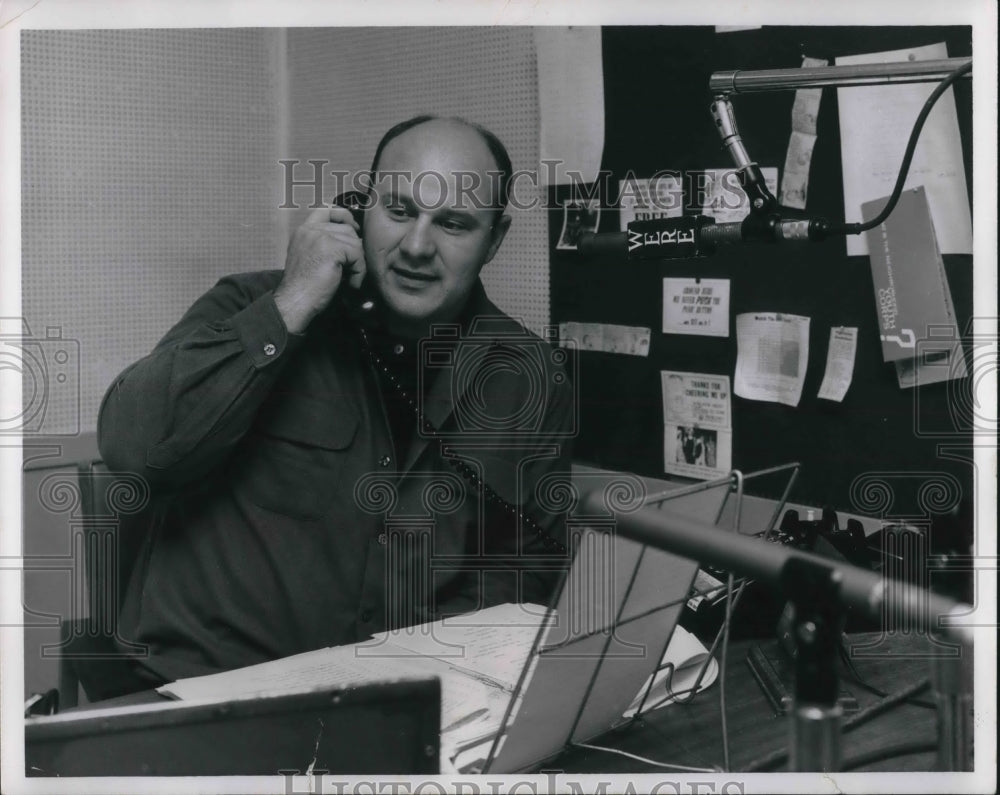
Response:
[98,271,575,680]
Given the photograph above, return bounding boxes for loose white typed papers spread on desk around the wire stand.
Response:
[159,604,718,762]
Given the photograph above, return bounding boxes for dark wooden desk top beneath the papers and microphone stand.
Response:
[50,633,948,773]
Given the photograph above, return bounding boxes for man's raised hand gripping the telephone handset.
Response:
[274,207,365,334]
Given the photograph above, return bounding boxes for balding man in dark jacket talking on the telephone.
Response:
[98,116,574,685]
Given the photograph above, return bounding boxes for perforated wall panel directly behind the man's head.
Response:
[288,27,549,331]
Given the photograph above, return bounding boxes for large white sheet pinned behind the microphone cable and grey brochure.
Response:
[837,43,972,255]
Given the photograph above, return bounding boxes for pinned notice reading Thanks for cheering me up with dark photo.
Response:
[660,370,733,479]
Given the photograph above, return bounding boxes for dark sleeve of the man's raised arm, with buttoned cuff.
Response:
[97,274,301,489]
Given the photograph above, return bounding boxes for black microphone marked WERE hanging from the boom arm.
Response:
[577,213,830,260]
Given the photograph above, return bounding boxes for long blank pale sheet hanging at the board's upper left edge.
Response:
[534,25,604,187]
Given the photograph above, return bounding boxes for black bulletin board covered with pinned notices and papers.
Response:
[549,27,973,517]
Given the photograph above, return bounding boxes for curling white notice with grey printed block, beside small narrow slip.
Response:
[733,312,809,406]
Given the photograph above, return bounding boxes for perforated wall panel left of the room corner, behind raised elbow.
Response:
[22,29,283,433]
